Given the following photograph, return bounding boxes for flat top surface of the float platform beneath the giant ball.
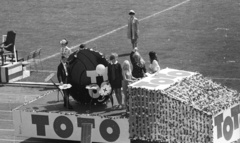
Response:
[18,90,126,117]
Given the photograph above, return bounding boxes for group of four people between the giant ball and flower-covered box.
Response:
[108,47,160,109]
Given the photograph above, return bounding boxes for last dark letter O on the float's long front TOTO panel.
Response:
[99,119,120,142]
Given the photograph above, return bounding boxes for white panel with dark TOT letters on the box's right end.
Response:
[213,104,240,143]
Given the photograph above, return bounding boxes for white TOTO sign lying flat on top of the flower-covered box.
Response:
[130,68,196,90]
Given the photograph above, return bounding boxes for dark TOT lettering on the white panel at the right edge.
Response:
[214,105,240,141]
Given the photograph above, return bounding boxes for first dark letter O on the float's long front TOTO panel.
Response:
[53,116,73,138]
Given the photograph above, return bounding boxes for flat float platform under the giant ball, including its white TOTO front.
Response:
[12,90,130,143]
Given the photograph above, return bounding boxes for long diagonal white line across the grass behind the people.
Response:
[41,0,190,61]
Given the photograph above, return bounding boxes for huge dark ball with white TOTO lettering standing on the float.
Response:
[68,48,112,104]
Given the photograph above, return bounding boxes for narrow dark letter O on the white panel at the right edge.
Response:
[223,116,233,141]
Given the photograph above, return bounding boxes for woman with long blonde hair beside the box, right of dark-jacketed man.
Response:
[122,60,136,108]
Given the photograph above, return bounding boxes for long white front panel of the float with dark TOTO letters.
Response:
[13,110,130,143]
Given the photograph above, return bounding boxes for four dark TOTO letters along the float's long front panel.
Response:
[32,115,120,142]
